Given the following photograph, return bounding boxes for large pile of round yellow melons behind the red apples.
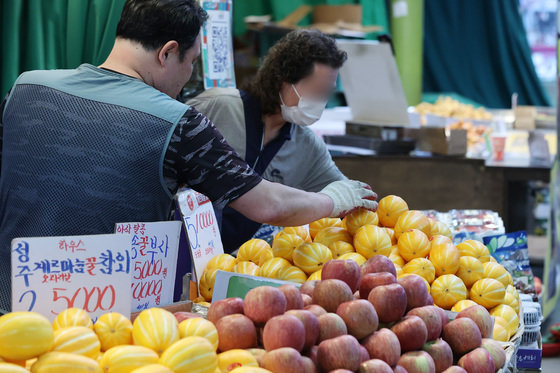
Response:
[199,195,519,340]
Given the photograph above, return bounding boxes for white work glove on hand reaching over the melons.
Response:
[319,180,377,218]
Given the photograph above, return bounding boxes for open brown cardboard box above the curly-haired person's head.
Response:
[246,4,383,38]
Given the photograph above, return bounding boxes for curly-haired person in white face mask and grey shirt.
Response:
[188,30,370,252]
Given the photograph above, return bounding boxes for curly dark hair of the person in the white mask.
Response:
[247,30,347,115]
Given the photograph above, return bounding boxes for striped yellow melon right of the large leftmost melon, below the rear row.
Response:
[52,326,101,359]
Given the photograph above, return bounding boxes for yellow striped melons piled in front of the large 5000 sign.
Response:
[0,308,252,373]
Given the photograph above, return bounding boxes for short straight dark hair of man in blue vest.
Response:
[117,0,208,60]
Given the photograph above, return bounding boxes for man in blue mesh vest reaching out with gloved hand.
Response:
[0,0,377,310]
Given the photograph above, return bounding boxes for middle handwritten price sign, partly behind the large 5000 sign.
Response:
[115,221,181,312]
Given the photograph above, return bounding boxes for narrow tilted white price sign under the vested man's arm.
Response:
[176,189,224,279]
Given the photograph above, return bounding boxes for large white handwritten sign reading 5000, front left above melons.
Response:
[11,235,133,321]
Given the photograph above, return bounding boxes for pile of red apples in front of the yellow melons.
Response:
[196,255,506,373]
